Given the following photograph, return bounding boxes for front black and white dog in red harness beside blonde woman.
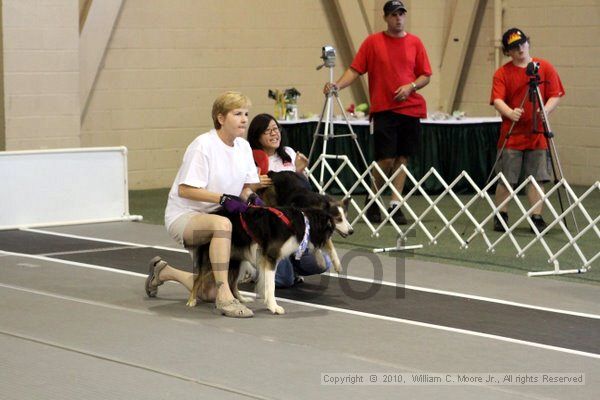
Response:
[187,207,352,314]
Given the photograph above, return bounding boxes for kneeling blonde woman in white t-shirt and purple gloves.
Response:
[146,92,269,317]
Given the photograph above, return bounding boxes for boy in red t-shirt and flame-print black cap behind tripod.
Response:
[490,28,565,232]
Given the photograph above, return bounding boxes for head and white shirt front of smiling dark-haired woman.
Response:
[248,114,308,174]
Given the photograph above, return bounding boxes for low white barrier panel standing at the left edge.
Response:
[0,147,142,230]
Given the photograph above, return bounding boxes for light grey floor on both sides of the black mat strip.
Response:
[0,223,600,399]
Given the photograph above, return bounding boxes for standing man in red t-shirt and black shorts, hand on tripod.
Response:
[323,0,431,225]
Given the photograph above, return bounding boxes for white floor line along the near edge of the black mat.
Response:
[0,252,600,359]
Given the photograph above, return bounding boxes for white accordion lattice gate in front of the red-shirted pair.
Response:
[309,154,600,276]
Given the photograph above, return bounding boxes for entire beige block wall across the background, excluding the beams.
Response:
[3,0,600,188]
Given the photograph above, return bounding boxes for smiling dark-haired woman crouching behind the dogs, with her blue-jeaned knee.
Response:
[248,114,331,288]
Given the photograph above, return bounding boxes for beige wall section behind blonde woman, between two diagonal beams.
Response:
[82,0,360,188]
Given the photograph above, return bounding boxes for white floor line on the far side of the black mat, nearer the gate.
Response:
[17,229,600,319]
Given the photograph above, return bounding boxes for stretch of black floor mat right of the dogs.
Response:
[277,276,600,354]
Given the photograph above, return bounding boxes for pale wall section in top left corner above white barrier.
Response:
[2,0,80,150]
